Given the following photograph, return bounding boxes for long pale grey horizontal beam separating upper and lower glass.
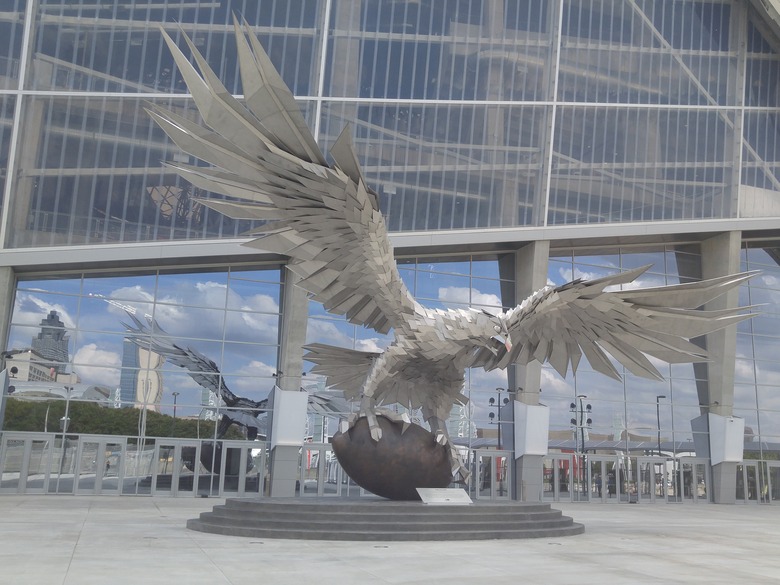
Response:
[0,218,780,274]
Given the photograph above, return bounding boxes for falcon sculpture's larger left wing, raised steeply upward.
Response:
[149,22,416,333]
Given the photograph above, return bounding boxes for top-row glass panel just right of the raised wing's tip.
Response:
[336,0,551,100]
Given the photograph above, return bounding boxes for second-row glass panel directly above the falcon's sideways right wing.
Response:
[548,107,735,224]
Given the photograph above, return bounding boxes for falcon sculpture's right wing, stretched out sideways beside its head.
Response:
[488,266,755,379]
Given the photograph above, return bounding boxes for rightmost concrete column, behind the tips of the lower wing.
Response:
[700,231,742,504]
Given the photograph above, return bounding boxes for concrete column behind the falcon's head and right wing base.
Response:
[509,241,550,502]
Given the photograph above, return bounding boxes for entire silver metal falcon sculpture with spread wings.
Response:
[148,19,752,478]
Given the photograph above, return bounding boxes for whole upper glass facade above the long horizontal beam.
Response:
[0,0,780,248]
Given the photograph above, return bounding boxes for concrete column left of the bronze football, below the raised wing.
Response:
[269,269,309,497]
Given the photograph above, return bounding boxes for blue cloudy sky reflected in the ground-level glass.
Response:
[8,249,780,448]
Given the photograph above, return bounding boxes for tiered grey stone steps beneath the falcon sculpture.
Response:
[187,498,584,541]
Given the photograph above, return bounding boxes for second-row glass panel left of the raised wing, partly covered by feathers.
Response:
[10,96,270,247]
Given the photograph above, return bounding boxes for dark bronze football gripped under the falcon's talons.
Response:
[333,415,452,500]
